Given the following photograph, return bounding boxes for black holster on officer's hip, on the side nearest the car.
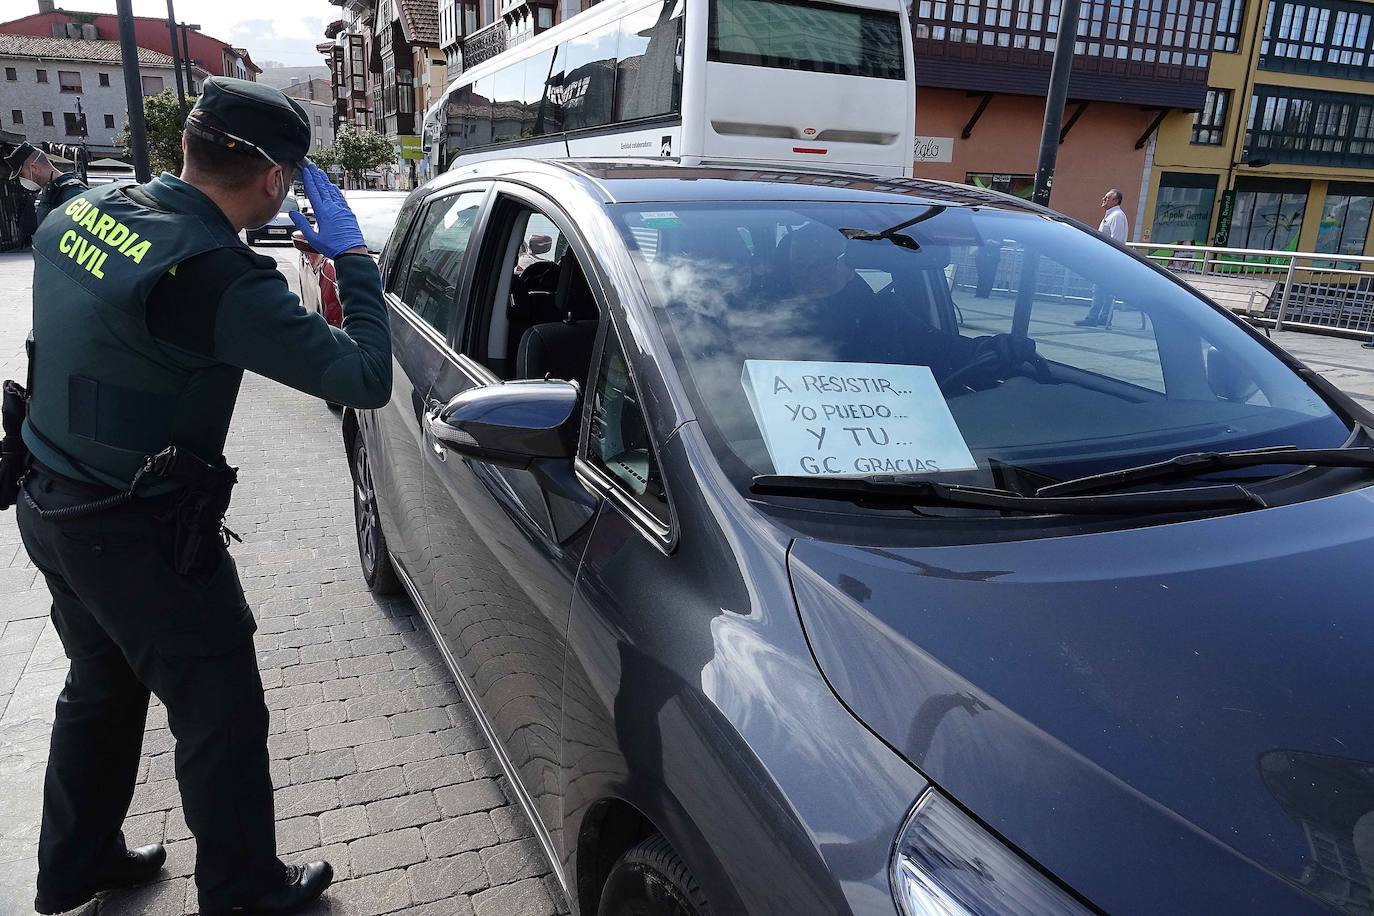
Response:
[132,445,242,575]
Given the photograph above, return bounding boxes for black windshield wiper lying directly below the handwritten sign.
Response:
[749,474,1265,515]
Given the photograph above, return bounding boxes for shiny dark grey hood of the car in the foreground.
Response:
[789,490,1374,916]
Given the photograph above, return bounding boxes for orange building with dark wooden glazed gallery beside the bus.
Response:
[912,0,1224,232]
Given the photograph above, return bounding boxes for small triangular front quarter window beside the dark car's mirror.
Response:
[587,331,668,525]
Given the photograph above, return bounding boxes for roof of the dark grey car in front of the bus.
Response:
[427,158,1051,216]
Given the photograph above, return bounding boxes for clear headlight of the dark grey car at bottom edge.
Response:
[892,788,1092,916]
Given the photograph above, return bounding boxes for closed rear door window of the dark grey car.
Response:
[396,191,485,336]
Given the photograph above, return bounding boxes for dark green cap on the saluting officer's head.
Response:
[185,77,311,166]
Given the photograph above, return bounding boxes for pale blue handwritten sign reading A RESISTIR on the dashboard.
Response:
[741,360,977,477]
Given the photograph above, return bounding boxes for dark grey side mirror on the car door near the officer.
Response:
[429,379,581,468]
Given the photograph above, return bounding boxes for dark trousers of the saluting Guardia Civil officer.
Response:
[16,468,283,908]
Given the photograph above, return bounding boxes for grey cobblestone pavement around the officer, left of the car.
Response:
[0,249,562,916]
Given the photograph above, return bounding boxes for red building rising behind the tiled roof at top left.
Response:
[0,0,262,80]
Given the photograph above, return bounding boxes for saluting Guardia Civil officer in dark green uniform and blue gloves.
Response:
[16,77,392,916]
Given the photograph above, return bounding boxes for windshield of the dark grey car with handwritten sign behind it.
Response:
[613,201,1349,486]
